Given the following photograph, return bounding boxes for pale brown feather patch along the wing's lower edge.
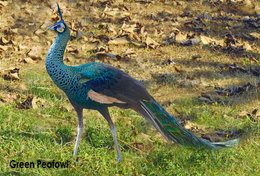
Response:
[88,90,126,104]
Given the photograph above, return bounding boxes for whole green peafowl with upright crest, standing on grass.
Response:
[45,4,238,162]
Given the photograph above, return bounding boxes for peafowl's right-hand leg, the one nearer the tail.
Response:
[99,108,122,162]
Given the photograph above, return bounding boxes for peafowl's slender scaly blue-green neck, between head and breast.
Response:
[45,27,70,65]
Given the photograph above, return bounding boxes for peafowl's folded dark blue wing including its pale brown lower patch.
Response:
[79,63,151,103]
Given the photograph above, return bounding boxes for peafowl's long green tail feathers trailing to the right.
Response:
[140,99,239,149]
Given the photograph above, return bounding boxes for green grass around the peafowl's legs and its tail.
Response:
[0,67,260,175]
